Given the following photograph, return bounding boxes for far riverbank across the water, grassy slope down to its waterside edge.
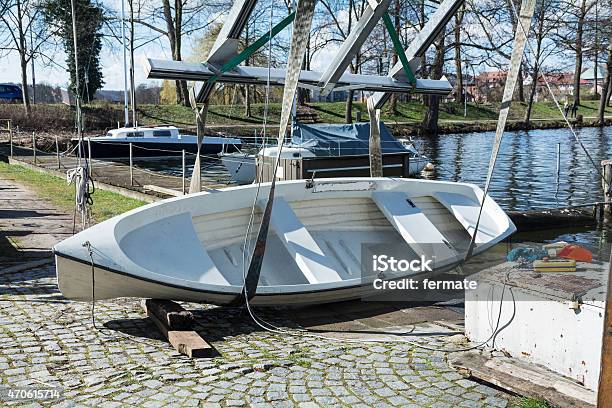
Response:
[0,101,612,139]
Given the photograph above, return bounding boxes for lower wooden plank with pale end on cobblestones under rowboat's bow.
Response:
[140,299,214,358]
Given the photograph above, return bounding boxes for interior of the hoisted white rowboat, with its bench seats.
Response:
[120,191,490,287]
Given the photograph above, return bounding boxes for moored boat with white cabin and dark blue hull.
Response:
[71,126,242,158]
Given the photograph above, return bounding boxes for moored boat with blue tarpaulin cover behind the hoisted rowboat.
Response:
[219,123,429,184]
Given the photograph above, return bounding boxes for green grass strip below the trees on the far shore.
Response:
[0,100,612,133]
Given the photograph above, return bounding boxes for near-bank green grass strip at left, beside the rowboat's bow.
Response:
[0,162,146,222]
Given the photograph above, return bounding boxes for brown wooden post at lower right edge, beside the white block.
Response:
[597,254,612,408]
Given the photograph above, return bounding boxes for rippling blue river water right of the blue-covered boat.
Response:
[417,127,612,210]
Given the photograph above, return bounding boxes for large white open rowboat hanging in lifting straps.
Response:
[53,178,515,305]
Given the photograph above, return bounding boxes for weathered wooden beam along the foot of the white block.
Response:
[449,352,592,408]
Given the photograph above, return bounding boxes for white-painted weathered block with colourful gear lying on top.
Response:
[465,262,609,404]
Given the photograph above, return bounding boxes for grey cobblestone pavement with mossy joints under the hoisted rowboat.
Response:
[0,265,511,408]
